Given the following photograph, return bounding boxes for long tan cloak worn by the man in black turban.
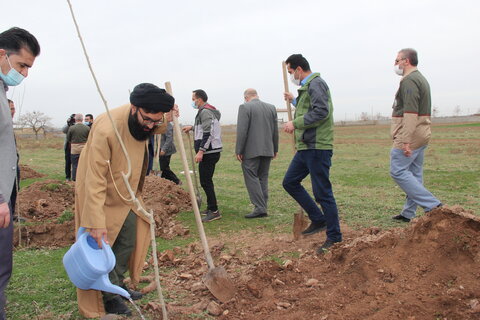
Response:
[75,105,166,318]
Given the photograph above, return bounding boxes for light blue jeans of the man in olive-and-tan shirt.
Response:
[390,146,441,219]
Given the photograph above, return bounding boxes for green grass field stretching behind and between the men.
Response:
[7,123,480,319]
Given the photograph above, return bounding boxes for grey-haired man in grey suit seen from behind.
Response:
[235,89,278,218]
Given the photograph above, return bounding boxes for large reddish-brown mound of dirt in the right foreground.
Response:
[138,208,480,320]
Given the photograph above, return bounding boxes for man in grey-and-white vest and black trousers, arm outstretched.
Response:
[182,89,222,222]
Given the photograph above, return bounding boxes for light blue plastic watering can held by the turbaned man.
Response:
[63,227,130,299]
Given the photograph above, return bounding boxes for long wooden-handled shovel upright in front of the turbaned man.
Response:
[165,82,235,303]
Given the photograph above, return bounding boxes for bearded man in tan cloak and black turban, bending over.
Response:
[75,83,174,318]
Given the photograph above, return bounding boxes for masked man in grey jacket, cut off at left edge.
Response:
[0,27,40,320]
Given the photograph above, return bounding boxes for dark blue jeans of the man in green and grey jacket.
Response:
[283,149,342,242]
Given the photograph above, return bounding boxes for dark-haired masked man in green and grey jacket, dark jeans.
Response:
[283,54,342,254]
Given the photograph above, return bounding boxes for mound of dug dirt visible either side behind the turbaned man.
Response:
[14,176,190,247]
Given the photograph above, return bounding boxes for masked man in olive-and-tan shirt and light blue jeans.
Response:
[390,48,442,222]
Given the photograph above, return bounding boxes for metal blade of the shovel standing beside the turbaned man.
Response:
[202,267,236,303]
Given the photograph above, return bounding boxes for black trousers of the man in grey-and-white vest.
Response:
[198,152,220,211]
